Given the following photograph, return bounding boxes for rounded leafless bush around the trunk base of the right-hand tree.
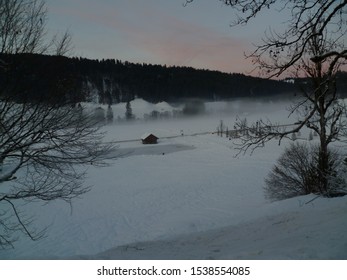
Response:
[264,143,346,200]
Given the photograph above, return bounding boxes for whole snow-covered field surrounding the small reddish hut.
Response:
[0,100,347,259]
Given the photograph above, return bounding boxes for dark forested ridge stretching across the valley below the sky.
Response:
[0,54,346,104]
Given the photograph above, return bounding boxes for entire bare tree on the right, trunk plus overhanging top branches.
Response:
[186,0,347,194]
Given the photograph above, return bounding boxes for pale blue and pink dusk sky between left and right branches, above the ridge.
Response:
[46,0,284,74]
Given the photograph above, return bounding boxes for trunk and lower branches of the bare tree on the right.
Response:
[236,27,347,193]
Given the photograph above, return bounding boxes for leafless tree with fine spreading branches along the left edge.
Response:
[0,0,115,248]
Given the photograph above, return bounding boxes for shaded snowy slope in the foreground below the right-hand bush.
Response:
[89,196,347,260]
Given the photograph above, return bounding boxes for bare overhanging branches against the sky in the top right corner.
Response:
[186,0,347,77]
